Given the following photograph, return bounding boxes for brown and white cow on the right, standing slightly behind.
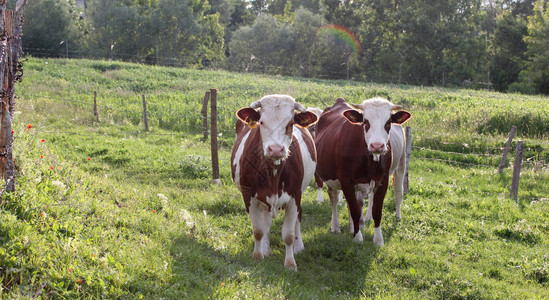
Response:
[315,98,411,246]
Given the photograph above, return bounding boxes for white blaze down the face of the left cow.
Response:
[255,95,296,158]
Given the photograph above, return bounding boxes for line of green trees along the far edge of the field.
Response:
[10,0,549,94]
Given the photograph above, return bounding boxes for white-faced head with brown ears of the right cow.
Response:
[343,98,412,161]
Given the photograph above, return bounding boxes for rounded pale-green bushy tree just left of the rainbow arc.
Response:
[226,7,333,77]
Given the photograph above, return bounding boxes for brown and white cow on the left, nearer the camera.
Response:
[231,95,317,270]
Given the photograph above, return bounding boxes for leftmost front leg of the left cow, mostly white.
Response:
[250,198,272,260]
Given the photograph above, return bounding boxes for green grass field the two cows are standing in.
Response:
[0,58,549,299]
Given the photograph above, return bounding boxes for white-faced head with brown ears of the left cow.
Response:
[236,95,318,163]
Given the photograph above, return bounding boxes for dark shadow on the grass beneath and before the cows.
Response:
[166,197,398,298]
